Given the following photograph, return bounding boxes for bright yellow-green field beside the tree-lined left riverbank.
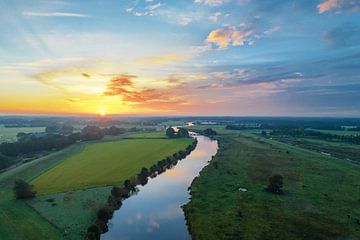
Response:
[31,138,192,195]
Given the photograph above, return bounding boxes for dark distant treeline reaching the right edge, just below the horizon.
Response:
[270,128,360,144]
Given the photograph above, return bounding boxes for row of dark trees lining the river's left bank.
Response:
[86,139,197,240]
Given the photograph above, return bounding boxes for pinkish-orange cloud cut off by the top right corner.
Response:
[317,0,360,14]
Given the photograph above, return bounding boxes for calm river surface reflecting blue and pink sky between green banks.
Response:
[101,137,217,240]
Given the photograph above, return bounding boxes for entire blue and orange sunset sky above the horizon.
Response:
[0,0,360,117]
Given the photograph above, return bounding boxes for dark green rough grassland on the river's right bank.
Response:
[185,134,360,240]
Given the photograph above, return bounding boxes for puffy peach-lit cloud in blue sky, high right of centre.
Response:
[206,27,253,48]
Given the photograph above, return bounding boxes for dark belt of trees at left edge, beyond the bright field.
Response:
[0,126,126,169]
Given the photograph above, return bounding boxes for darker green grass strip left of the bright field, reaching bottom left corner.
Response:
[0,145,82,240]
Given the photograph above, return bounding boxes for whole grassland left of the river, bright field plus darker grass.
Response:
[0,132,192,240]
